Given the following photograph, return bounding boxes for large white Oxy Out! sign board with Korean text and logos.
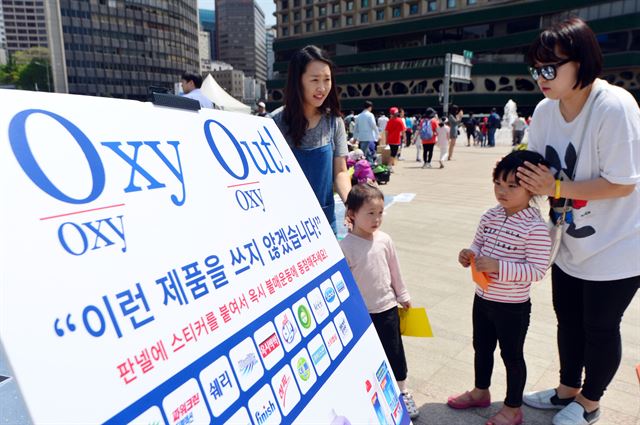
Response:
[0,90,410,425]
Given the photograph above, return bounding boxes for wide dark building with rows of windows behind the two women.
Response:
[268,0,640,113]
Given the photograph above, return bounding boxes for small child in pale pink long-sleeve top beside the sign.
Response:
[340,183,419,419]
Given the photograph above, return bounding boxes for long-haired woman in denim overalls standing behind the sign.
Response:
[272,46,351,234]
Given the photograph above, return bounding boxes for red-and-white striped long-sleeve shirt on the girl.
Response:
[470,205,551,303]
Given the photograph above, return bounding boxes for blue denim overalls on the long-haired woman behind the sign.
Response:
[293,117,337,233]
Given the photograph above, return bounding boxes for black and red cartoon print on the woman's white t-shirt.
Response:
[544,142,596,239]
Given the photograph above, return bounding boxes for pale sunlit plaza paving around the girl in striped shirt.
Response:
[381,134,640,425]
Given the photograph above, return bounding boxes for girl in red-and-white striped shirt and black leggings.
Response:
[447,151,551,425]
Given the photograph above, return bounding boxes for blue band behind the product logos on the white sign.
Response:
[105,259,378,425]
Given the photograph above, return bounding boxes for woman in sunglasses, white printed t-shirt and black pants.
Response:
[518,18,640,425]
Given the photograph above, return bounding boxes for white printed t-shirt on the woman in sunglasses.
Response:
[529,79,640,281]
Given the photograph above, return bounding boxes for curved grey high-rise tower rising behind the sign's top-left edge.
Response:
[48,0,199,100]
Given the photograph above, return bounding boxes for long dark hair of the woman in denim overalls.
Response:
[283,46,340,146]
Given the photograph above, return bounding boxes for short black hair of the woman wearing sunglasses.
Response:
[527,17,602,89]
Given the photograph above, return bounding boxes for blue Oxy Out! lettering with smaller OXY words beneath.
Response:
[9,109,290,256]
